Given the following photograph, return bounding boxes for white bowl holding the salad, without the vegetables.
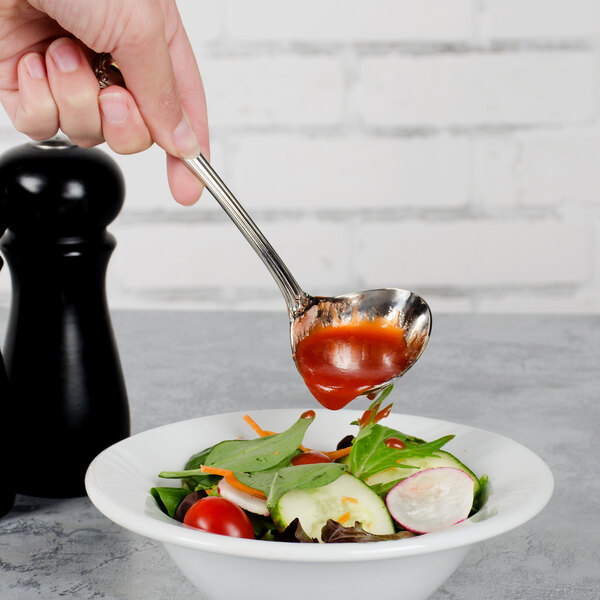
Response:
[85,409,554,600]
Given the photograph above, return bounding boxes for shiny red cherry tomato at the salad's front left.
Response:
[183,496,254,540]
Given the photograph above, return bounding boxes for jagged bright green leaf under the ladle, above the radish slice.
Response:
[350,424,454,481]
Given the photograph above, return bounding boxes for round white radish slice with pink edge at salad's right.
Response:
[385,467,475,533]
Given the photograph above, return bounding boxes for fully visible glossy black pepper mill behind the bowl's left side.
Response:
[0,138,129,497]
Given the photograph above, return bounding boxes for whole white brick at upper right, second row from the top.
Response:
[357,51,595,127]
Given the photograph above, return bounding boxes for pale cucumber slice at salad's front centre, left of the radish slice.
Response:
[271,473,394,540]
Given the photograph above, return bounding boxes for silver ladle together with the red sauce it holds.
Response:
[182,155,431,409]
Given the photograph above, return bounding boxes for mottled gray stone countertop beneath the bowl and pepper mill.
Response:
[0,311,600,600]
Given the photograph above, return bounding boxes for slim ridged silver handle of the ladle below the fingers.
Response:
[182,154,306,317]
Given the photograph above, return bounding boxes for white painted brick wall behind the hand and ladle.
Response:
[0,0,600,313]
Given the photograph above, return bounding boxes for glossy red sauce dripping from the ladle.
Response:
[296,321,409,410]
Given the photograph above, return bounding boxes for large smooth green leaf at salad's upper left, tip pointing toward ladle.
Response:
[204,417,314,473]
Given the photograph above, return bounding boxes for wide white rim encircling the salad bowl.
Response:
[85,408,554,562]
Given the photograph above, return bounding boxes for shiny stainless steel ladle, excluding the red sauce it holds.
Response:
[182,154,431,395]
